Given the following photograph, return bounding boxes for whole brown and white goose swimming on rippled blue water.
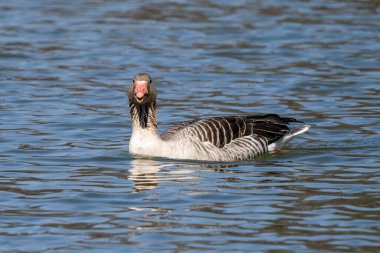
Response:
[128,73,310,162]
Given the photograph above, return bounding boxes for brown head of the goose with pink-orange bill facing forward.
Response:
[128,73,157,106]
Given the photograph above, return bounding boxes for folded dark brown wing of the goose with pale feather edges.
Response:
[161,114,300,148]
